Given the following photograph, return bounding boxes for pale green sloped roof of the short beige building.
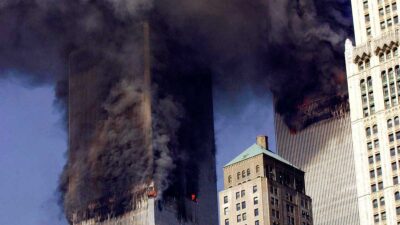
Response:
[224,144,300,170]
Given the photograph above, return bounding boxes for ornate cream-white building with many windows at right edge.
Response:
[345,0,400,225]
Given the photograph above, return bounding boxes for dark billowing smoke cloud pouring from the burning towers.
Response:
[0,0,351,221]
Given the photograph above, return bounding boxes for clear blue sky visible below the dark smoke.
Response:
[0,76,275,225]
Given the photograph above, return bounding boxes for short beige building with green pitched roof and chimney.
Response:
[219,136,313,225]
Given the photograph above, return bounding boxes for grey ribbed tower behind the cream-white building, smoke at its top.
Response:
[275,111,360,225]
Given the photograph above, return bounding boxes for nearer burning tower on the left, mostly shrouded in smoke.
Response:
[64,23,218,225]
